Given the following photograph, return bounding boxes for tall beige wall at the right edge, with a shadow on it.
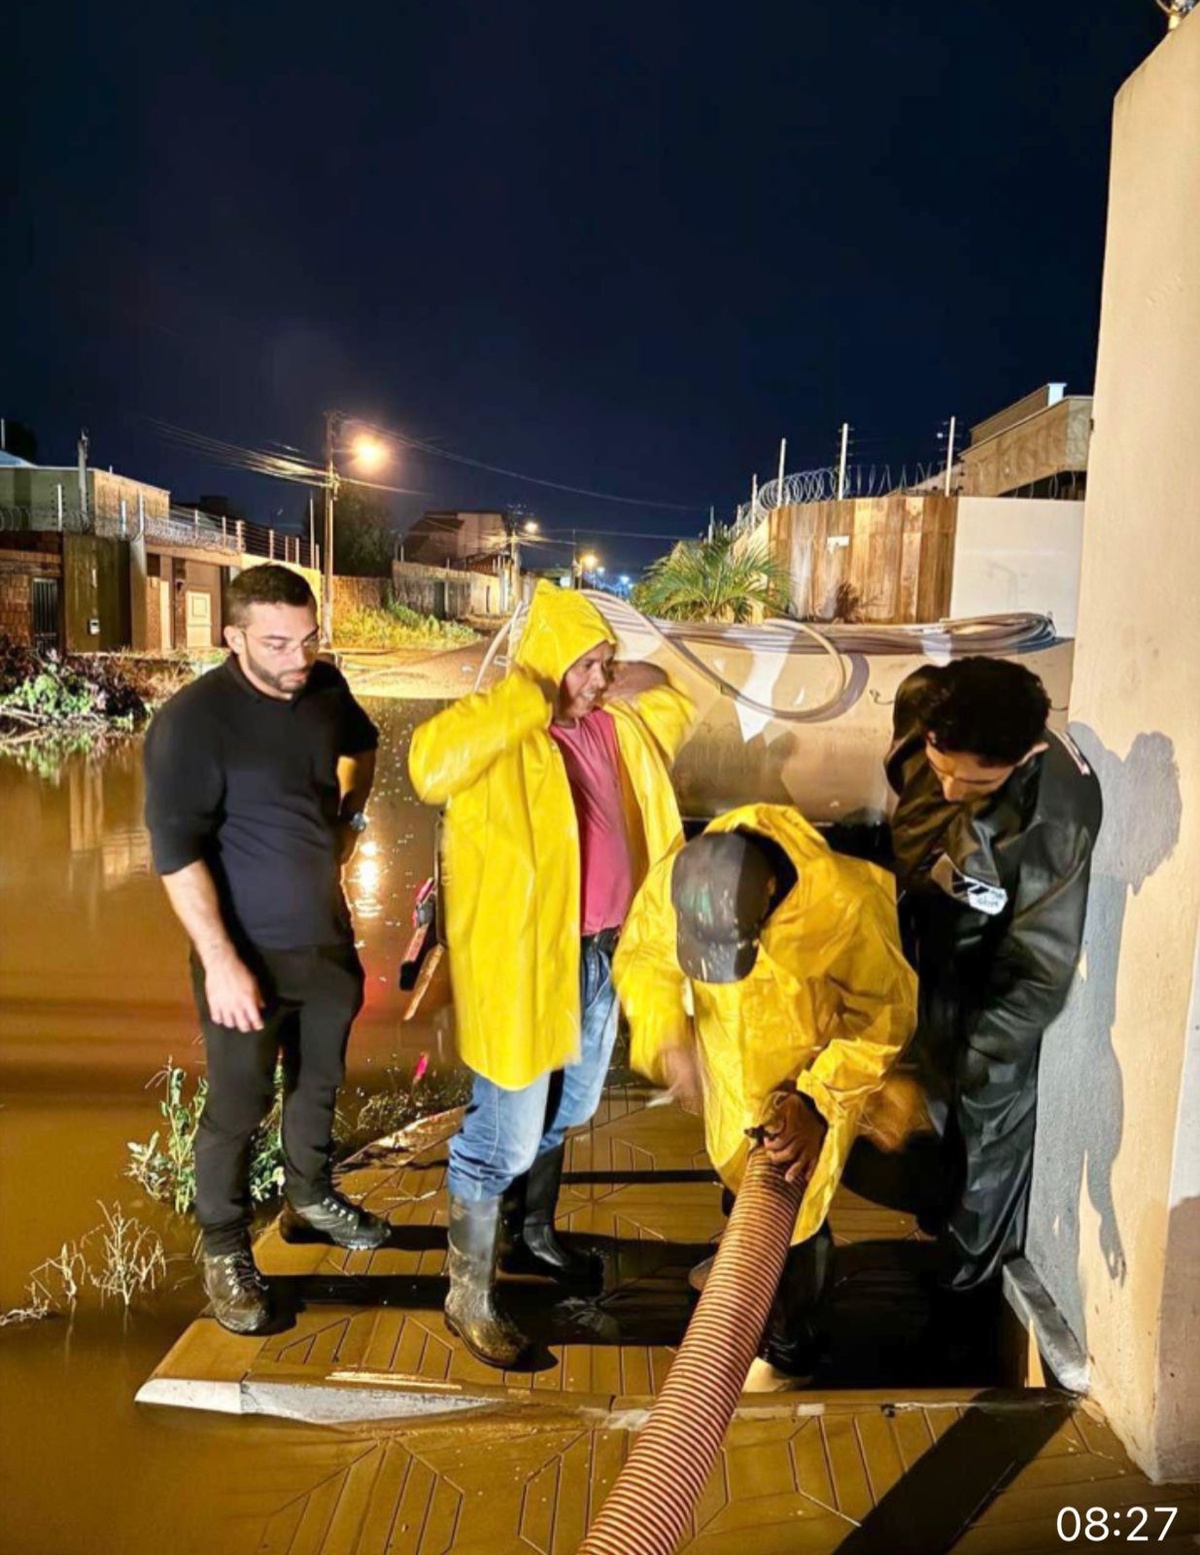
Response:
[1029,11,1200,1479]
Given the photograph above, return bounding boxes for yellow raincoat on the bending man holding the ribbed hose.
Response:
[614,804,925,1242]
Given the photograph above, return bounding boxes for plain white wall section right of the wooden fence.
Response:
[950,496,1083,638]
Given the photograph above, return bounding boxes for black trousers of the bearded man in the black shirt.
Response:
[191,944,364,1255]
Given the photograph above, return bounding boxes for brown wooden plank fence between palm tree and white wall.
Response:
[768,494,958,625]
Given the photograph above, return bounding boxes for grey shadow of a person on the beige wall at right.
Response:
[1029,725,1183,1348]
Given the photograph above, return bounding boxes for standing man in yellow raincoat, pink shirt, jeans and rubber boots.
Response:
[409,583,695,1367]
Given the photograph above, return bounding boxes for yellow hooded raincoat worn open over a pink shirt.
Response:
[409,583,695,1090]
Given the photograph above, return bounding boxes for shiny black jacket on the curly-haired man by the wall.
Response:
[886,670,1102,1092]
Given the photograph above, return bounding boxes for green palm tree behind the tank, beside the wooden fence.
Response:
[633,526,788,622]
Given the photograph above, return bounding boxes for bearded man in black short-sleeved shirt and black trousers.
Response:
[146,564,387,1333]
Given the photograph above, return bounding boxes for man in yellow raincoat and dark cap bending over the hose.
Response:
[614,804,922,1389]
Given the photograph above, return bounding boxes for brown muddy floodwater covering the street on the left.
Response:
[0,700,452,1555]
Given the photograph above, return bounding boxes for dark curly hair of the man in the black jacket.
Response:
[914,658,1051,767]
